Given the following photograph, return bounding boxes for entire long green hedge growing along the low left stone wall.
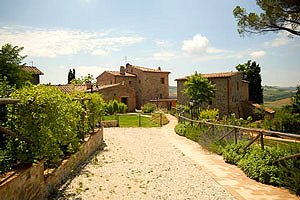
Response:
[0,85,104,173]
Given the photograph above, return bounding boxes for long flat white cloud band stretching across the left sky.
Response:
[0,26,144,57]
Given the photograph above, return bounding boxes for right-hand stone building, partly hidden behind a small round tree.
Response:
[176,72,248,117]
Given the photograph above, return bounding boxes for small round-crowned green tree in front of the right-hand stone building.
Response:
[183,72,216,105]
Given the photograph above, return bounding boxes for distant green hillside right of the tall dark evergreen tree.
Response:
[263,85,297,102]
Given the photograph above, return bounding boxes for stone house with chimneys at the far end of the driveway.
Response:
[96,63,170,111]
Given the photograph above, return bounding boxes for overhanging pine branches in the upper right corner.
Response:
[233,0,300,36]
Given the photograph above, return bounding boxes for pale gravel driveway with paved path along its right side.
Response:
[55,115,299,199]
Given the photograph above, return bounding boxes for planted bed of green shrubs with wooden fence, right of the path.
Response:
[175,109,300,195]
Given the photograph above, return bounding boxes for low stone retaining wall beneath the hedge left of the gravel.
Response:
[0,128,103,200]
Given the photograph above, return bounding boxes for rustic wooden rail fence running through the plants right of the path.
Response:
[171,110,300,162]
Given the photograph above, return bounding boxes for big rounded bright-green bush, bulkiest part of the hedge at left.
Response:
[7,85,84,164]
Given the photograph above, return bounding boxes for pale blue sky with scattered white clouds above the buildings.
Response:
[0,0,300,86]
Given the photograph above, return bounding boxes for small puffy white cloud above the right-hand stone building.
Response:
[182,34,225,55]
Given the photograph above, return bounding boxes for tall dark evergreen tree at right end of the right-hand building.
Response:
[235,60,263,103]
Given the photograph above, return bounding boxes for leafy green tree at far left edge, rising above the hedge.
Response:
[0,44,31,88]
